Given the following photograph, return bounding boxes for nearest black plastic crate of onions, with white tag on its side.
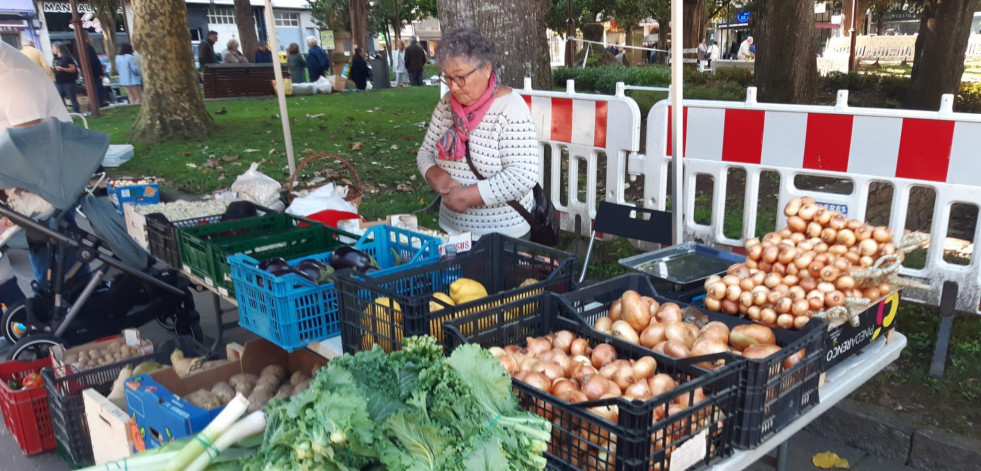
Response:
[443,293,745,471]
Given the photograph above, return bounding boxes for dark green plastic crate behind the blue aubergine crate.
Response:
[177,214,358,297]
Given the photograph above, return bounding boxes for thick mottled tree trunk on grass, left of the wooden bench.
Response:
[130,0,215,142]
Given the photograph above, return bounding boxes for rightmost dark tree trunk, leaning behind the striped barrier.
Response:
[904,0,979,110]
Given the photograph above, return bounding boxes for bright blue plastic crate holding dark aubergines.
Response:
[228,225,442,351]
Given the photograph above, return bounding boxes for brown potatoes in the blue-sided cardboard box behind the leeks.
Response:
[184,365,319,412]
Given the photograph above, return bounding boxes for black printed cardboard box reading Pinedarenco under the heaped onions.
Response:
[822,291,899,371]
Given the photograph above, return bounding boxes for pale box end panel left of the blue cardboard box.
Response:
[82,389,133,465]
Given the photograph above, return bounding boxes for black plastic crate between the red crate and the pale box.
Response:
[41,353,170,467]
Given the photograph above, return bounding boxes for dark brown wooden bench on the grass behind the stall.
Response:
[204,64,286,98]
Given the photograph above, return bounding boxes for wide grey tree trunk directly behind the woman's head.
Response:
[436,0,552,90]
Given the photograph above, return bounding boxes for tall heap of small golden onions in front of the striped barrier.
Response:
[705,197,902,329]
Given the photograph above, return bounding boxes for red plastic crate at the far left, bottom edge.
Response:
[0,358,55,455]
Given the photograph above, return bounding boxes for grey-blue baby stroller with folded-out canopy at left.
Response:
[0,119,202,360]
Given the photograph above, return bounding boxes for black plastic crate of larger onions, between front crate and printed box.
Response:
[561,274,828,449]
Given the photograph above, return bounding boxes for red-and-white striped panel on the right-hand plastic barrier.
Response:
[664,106,981,186]
